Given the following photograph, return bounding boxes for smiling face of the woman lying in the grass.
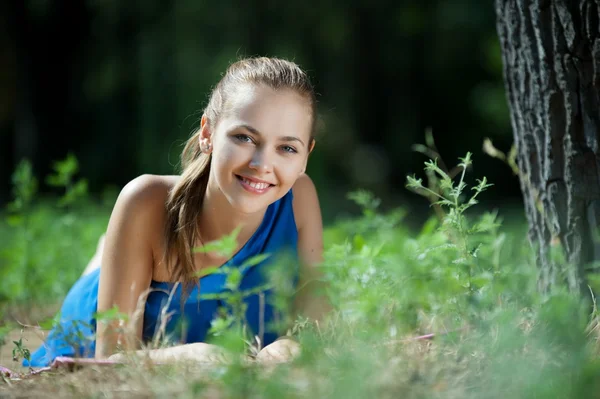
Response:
[201,85,312,214]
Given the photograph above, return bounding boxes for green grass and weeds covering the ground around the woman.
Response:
[0,156,600,398]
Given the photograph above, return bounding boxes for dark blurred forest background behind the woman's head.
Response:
[0,0,520,220]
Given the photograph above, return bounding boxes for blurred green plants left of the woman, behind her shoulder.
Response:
[0,155,111,325]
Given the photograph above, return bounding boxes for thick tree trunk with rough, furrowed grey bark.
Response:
[496,0,600,293]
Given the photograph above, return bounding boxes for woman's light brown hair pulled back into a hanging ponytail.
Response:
[163,57,317,288]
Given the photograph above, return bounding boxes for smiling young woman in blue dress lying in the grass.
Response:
[25,58,323,366]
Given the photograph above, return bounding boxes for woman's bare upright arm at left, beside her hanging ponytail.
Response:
[95,175,168,359]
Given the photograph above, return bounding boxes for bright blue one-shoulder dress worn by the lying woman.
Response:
[23,190,298,367]
